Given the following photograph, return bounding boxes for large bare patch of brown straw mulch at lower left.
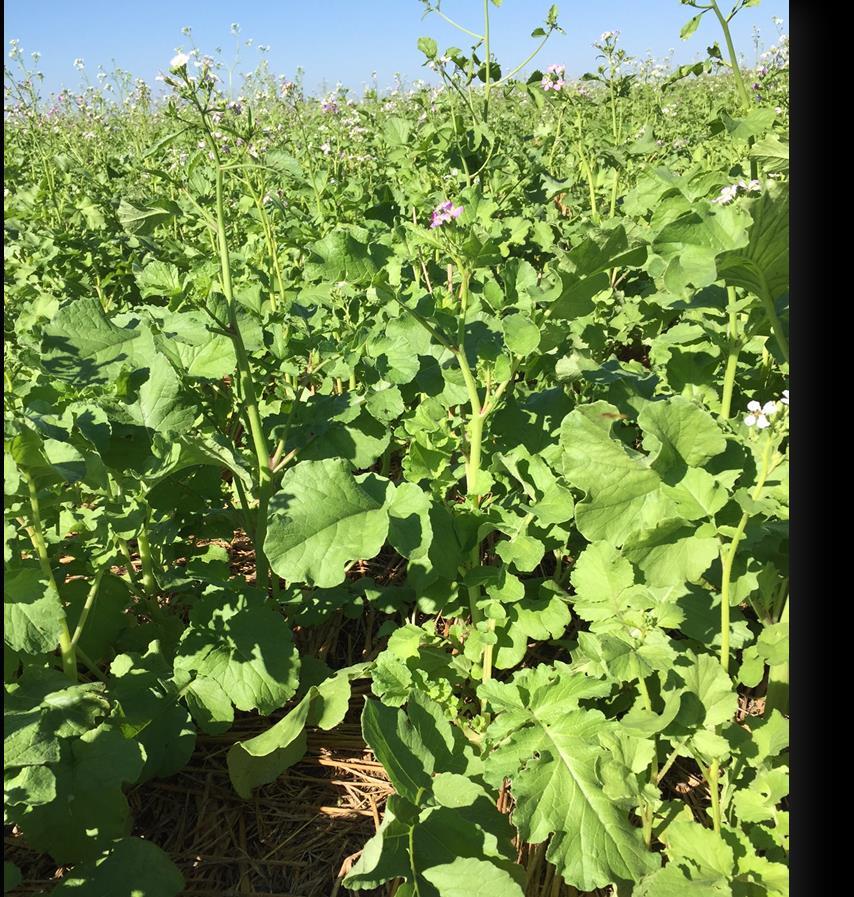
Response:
[5,695,392,897]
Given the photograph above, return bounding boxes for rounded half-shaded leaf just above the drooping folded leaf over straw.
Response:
[175,588,299,714]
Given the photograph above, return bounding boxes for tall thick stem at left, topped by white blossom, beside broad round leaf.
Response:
[210,156,273,590]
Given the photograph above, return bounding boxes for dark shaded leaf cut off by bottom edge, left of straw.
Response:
[50,838,184,897]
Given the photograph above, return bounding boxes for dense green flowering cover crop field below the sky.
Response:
[3,0,789,897]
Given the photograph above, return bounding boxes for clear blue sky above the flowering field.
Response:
[4,0,788,94]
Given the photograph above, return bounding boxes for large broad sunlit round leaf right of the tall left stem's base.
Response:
[264,459,389,588]
